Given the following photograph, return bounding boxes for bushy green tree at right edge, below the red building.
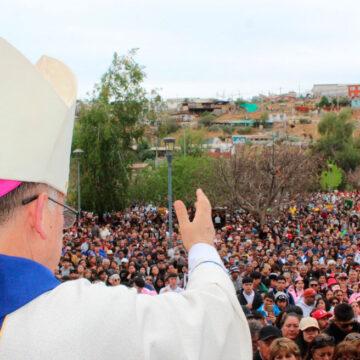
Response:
[314,109,360,172]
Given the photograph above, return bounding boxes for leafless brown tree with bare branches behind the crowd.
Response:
[207,145,318,225]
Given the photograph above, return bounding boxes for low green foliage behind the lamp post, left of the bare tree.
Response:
[130,156,214,207]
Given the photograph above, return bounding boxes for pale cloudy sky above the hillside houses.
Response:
[0,0,360,99]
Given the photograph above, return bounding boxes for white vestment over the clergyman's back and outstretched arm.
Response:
[0,246,252,360]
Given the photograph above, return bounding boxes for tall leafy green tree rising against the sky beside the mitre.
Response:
[73,50,149,215]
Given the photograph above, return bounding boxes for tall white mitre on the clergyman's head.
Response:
[0,38,77,193]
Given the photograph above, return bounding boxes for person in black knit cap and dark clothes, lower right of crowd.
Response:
[324,303,360,345]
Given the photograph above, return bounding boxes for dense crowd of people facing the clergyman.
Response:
[59,192,360,360]
